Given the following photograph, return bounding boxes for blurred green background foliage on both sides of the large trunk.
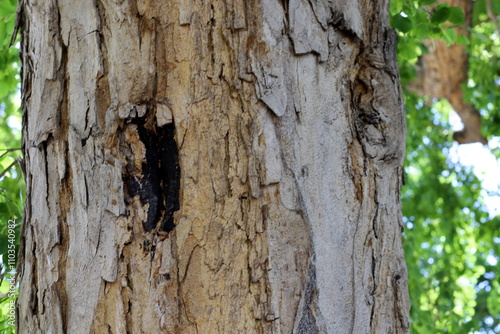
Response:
[0,0,500,334]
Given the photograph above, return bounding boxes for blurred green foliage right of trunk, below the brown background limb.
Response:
[403,94,500,333]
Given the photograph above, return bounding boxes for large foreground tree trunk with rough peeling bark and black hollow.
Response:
[18,0,409,334]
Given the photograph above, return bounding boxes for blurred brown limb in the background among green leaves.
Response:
[408,0,488,145]
